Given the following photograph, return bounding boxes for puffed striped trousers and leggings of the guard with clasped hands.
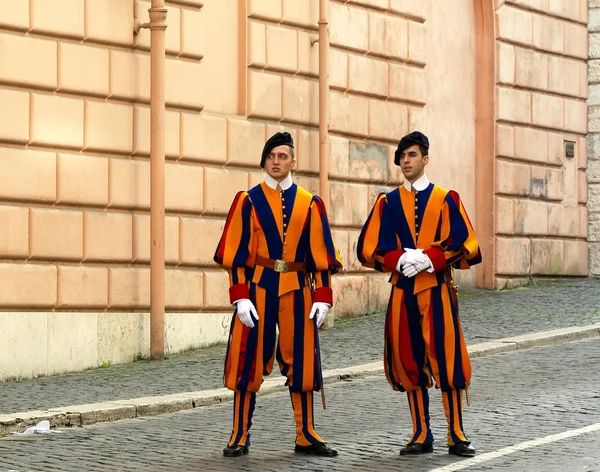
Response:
[384,282,471,446]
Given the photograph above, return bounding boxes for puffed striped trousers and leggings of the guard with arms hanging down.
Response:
[224,284,325,446]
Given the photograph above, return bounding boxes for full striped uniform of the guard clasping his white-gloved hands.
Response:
[357,183,481,445]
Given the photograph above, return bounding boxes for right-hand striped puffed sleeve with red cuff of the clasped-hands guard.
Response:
[425,190,482,272]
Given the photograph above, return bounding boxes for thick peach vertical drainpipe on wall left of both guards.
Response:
[148,0,167,359]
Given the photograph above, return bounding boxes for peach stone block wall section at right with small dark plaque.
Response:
[495,0,592,288]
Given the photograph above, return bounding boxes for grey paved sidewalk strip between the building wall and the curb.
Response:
[0,279,600,415]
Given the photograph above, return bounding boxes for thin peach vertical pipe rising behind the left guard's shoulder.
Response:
[319,0,329,208]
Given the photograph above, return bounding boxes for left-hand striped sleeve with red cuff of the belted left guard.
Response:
[213,192,253,303]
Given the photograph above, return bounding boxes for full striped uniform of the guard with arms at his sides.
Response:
[214,182,342,446]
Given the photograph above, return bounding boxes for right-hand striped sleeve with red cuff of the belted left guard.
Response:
[306,195,342,305]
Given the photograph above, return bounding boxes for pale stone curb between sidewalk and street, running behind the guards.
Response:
[0,323,600,435]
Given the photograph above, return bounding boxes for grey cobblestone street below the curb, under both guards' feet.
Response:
[0,338,600,472]
